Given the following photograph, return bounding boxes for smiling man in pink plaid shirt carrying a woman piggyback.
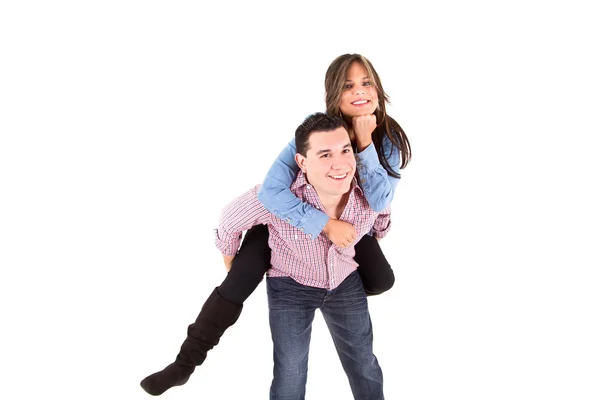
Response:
[216,113,390,400]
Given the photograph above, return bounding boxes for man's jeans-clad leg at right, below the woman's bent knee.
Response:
[321,272,383,400]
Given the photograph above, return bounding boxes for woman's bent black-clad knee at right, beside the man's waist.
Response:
[354,235,395,296]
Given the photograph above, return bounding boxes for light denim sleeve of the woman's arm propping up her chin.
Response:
[356,138,400,212]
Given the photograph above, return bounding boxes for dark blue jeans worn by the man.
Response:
[267,271,383,400]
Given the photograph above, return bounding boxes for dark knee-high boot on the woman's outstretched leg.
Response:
[140,288,243,396]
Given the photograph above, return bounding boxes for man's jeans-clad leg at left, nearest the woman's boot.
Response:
[267,277,324,400]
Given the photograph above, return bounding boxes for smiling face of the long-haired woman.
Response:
[340,61,379,118]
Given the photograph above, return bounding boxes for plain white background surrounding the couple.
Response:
[0,0,600,400]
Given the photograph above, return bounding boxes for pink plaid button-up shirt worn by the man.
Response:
[215,172,391,290]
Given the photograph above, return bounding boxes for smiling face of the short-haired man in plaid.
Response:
[296,127,356,196]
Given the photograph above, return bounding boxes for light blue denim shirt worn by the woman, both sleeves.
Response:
[258,137,400,238]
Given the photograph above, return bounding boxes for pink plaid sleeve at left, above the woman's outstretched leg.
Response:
[215,185,271,256]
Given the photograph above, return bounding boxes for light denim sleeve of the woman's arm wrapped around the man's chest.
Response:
[258,140,329,238]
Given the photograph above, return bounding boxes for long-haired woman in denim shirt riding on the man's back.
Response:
[141,54,411,396]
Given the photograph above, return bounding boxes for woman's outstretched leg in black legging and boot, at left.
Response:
[140,225,271,396]
